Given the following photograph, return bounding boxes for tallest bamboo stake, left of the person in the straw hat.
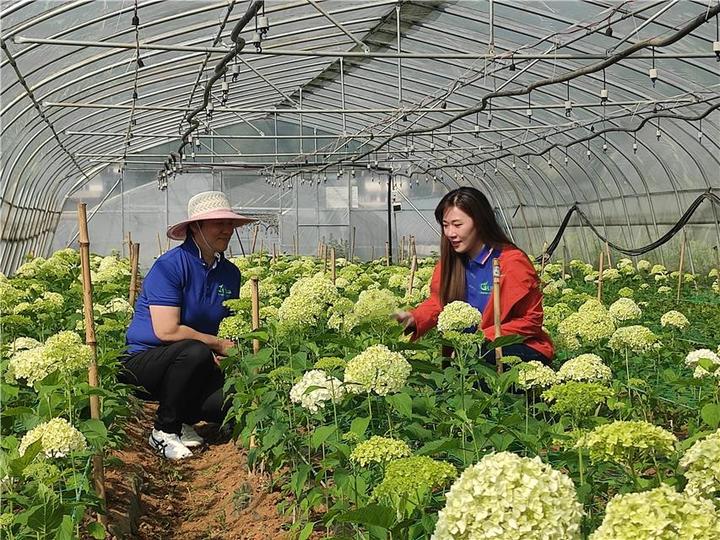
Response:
[77,203,107,526]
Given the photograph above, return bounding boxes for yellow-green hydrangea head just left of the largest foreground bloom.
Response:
[373,456,457,507]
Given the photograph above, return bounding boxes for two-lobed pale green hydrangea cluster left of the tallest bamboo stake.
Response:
[7,331,92,386]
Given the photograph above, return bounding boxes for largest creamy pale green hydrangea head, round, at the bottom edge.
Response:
[432,452,583,540]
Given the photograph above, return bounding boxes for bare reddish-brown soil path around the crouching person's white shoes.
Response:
[106,404,288,540]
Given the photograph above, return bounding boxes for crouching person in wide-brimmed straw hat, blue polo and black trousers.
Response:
[121,191,253,459]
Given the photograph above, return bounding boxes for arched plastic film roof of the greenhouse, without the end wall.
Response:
[0,0,720,271]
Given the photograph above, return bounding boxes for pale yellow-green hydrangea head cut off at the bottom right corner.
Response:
[590,484,720,540]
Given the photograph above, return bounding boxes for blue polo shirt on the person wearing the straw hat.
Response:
[125,237,240,354]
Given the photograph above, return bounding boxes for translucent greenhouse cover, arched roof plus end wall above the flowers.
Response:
[0,0,720,273]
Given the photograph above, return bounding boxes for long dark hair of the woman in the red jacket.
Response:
[435,186,515,305]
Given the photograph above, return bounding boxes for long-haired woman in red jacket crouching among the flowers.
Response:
[396,187,554,364]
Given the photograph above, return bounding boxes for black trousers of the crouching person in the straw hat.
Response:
[118,339,227,435]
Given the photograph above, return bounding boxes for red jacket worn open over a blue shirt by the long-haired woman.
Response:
[411,247,555,358]
